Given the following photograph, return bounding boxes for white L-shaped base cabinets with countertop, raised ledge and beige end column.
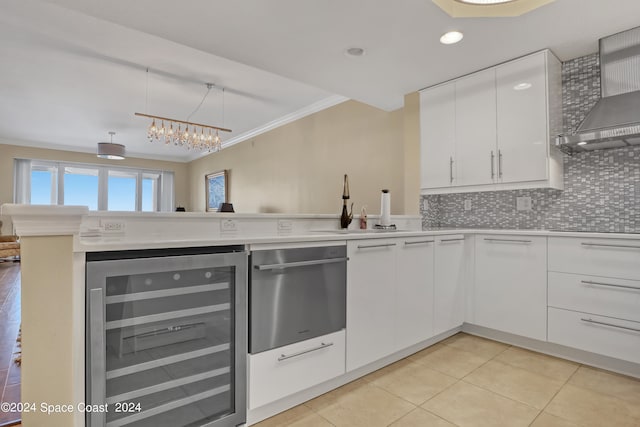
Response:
[2,205,640,427]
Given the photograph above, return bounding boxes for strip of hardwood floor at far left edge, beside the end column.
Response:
[0,261,20,426]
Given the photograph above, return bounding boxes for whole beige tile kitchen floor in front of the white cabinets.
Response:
[256,333,640,427]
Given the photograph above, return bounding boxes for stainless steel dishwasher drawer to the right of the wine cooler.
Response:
[249,245,347,353]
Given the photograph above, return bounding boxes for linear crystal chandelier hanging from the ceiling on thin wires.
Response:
[135,82,231,152]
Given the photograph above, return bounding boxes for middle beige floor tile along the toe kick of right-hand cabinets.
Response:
[495,347,580,381]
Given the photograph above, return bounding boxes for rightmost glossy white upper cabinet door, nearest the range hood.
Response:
[496,52,549,182]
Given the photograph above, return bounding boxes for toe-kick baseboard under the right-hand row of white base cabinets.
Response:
[462,323,640,378]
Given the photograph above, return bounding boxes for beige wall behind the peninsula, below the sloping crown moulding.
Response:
[190,101,408,214]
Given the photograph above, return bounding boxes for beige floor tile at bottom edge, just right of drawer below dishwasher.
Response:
[316,384,416,427]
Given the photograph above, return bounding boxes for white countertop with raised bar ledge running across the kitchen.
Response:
[2,204,640,252]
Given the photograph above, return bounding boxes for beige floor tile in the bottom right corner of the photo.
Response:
[545,384,640,427]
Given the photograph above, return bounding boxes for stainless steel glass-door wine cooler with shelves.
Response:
[86,246,247,427]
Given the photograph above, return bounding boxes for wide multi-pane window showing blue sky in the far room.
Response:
[14,159,174,212]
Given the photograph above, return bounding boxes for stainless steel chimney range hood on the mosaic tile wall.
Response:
[556,27,640,154]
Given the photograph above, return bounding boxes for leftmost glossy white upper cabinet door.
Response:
[420,83,456,188]
